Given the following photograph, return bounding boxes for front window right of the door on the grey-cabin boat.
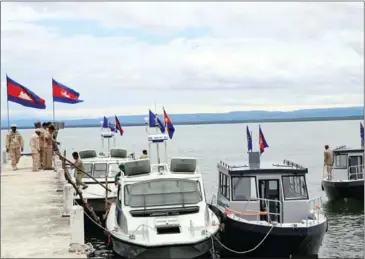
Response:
[283,175,308,200]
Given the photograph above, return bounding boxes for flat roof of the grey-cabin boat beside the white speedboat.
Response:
[217,159,308,176]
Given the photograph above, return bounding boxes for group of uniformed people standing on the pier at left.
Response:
[5,121,59,171]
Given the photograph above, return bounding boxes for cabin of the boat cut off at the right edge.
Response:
[324,146,364,181]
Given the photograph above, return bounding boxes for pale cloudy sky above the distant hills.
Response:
[1,2,364,118]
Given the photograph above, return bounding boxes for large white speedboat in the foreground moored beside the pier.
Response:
[106,118,219,258]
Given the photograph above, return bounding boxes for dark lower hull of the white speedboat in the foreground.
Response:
[111,236,212,259]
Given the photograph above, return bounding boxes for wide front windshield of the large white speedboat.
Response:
[124,179,203,208]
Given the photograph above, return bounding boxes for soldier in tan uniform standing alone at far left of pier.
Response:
[5,124,24,171]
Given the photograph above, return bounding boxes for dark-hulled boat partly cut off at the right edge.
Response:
[322,146,364,201]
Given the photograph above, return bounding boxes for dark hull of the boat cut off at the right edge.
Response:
[322,180,364,201]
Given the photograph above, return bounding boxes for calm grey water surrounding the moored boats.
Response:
[1,121,364,258]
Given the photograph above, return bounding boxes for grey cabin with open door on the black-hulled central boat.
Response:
[217,152,310,223]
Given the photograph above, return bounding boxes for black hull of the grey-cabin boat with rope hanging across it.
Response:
[212,207,327,258]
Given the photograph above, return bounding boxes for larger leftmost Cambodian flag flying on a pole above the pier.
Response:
[6,76,46,109]
